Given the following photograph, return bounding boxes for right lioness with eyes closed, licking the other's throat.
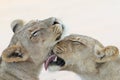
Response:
[45,34,120,80]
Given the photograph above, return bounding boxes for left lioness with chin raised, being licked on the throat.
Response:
[0,17,64,80]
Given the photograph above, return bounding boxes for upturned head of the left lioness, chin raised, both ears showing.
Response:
[2,17,64,64]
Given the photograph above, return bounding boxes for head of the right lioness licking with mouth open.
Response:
[45,34,119,73]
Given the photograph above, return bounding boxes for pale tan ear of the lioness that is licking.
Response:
[95,46,119,63]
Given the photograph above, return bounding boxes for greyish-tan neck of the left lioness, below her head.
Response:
[1,62,39,80]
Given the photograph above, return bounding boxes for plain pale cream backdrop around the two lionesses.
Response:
[0,0,120,80]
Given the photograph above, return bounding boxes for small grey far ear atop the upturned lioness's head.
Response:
[11,20,23,33]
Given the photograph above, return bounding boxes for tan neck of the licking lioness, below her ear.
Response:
[79,58,120,80]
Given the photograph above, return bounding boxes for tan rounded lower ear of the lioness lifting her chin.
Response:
[2,43,29,62]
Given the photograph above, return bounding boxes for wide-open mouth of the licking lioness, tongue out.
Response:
[44,54,65,70]
